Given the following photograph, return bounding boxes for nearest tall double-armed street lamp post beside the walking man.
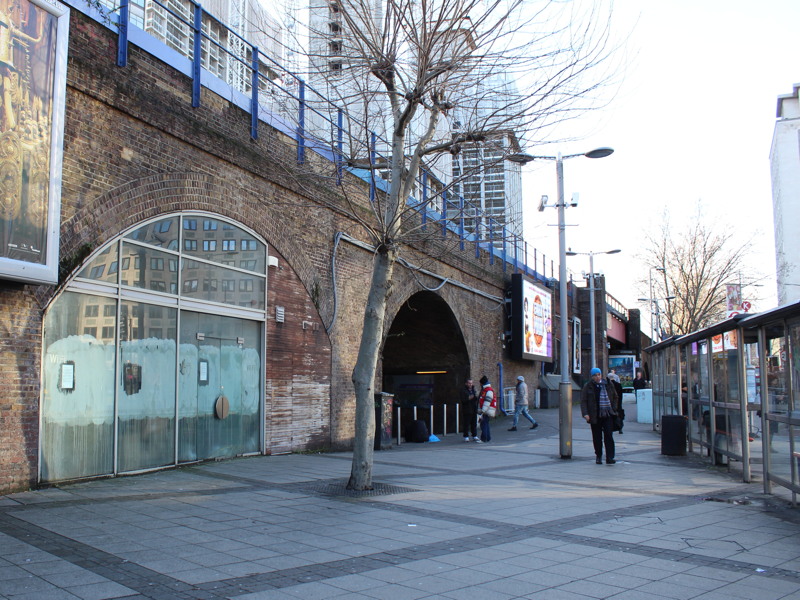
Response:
[526,148,614,458]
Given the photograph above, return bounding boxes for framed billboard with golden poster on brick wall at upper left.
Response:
[0,0,69,283]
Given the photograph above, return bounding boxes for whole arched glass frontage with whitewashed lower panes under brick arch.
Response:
[40,214,266,481]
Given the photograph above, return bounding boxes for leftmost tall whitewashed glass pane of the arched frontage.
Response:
[40,292,116,481]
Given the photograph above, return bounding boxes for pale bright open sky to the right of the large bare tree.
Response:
[524,0,800,322]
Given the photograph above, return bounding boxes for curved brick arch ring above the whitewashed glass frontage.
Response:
[48,171,316,310]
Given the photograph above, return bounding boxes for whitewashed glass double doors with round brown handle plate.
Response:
[178,311,261,462]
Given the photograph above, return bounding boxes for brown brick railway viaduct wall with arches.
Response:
[0,9,538,493]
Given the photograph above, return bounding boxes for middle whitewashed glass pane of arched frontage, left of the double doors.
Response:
[117,301,178,472]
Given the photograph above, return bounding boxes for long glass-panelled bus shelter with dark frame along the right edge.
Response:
[648,302,800,503]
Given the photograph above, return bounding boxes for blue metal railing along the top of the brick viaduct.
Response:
[95,0,553,281]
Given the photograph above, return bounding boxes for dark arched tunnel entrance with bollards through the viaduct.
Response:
[383,292,470,436]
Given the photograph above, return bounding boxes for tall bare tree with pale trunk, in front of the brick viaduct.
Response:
[268,0,612,490]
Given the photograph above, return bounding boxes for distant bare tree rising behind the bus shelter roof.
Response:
[644,209,754,335]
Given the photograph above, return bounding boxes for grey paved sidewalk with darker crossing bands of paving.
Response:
[0,406,800,600]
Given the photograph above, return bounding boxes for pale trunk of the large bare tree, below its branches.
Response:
[347,248,395,491]
